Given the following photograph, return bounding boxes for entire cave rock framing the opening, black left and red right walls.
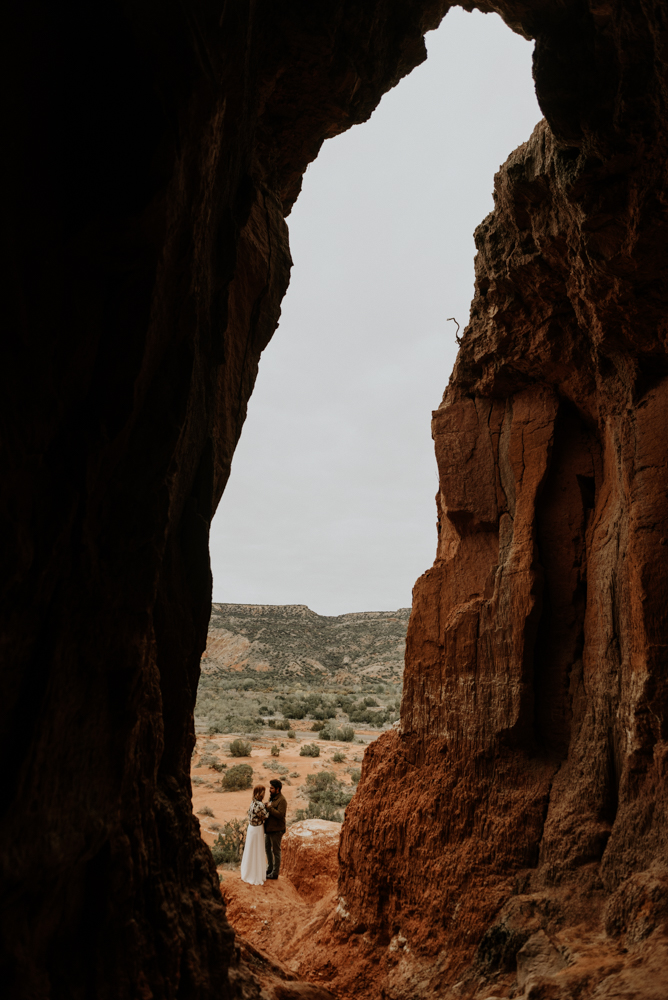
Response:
[0,0,668,1000]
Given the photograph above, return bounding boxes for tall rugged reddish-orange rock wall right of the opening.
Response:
[340,4,668,998]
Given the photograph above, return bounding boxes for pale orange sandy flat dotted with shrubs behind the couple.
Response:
[191,730,380,846]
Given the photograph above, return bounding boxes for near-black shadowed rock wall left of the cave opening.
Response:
[0,0,444,1000]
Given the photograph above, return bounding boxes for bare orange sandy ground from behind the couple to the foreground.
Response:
[192,730,668,1000]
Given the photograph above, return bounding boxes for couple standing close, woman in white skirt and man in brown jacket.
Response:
[241,778,288,885]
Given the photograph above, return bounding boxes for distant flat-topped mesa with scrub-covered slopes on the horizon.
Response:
[202,604,411,683]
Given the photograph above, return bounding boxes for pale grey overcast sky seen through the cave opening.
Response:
[211,8,542,615]
